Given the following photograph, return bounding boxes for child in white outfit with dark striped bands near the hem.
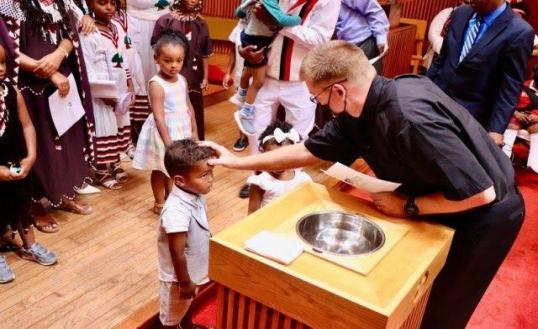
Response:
[81,0,134,189]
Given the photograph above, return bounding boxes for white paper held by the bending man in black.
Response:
[323,162,402,193]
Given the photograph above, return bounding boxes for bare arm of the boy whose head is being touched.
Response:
[168,232,196,299]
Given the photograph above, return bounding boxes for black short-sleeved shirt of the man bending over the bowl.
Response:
[305,75,515,215]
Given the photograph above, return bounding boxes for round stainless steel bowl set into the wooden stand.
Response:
[296,211,385,256]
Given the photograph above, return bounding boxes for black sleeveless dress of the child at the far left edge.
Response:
[0,82,32,236]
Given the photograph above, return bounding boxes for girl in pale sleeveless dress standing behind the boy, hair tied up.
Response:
[133,30,198,214]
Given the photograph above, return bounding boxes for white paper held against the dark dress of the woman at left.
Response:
[49,74,85,136]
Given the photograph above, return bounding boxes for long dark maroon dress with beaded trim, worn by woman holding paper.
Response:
[11,3,94,206]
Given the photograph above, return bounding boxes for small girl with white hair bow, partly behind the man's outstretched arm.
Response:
[247,120,312,214]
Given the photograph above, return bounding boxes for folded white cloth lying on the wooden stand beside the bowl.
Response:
[245,231,303,265]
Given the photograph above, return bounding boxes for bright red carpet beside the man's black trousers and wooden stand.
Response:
[194,165,538,329]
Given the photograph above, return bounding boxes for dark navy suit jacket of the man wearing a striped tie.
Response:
[427,6,534,134]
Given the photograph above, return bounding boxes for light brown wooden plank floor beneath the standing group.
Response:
[0,96,326,329]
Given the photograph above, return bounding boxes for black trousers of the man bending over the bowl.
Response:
[421,191,525,329]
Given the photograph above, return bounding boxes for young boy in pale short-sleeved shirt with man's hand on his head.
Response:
[158,139,214,328]
